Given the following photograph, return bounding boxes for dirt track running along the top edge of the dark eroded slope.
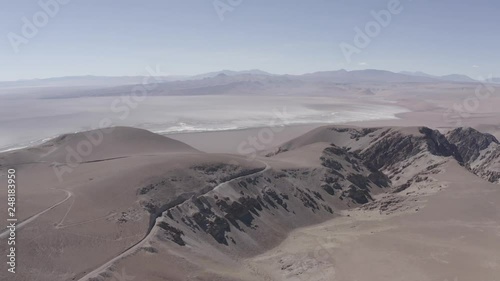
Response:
[78,160,271,281]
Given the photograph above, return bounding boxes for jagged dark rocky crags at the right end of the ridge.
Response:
[290,127,500,185]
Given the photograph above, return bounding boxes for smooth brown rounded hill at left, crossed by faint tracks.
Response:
[0,127,264,280]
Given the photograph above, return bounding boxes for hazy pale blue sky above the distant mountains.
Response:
[0,0,500,80]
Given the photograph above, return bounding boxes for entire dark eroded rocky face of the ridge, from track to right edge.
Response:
[149,127,500,254]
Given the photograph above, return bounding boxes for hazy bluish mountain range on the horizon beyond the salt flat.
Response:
[29,69,494,98]
